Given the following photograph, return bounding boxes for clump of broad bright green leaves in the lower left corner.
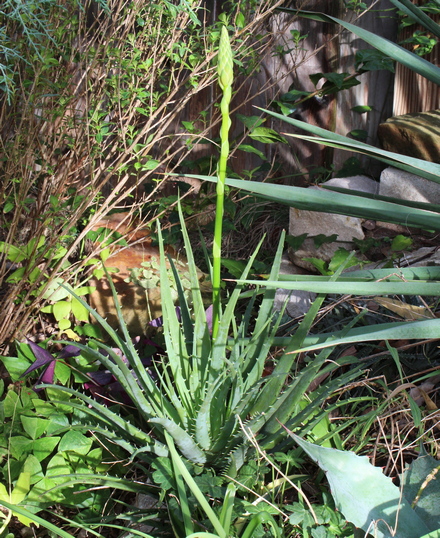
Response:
[0,387,110,526]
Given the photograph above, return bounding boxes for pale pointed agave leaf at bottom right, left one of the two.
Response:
[288,432,430,538]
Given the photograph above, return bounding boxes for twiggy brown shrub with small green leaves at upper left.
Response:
[0,0,292,352]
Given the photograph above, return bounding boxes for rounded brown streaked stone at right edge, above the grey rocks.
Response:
[377,110,440,163]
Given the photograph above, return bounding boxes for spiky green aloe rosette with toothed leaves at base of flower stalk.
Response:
[38,202,359,475]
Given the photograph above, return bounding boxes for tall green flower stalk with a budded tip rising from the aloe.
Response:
[212,26,234,340]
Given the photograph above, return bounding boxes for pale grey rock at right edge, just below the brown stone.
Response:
[379,166,440,204]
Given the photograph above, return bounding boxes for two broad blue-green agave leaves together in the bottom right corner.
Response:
[291,433,440,538]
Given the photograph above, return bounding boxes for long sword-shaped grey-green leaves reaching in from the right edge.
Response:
[185,0,440,356]
